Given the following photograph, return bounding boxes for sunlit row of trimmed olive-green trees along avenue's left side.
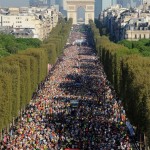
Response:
[0,20,72,135]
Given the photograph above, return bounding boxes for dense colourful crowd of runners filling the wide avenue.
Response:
[0,25,131,150]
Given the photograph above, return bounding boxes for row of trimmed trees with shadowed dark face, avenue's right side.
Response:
[90,21,150,144]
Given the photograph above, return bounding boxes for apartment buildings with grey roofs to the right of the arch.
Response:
[100,5,150,42]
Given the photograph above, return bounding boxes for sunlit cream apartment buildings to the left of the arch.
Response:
[0,7,58,40]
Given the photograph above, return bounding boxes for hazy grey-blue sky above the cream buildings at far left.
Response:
[0,0,29,7]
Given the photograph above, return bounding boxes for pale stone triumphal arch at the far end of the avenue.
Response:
[66,0,95,24]
